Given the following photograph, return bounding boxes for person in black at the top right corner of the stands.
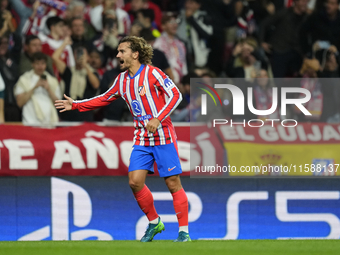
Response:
[299,0,340,57]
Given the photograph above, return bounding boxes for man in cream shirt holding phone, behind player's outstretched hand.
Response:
[14,52,61,125]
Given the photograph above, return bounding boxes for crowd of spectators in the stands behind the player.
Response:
[0,0,340,125]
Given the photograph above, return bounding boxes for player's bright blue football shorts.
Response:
[129,143,182,177]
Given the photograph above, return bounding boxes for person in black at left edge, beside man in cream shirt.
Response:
[0,36,21,121]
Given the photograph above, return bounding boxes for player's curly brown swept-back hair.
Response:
[119,36,153,65]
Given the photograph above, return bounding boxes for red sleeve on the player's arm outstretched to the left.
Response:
[72,74,121,112]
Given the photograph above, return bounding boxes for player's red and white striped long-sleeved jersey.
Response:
[72,65,182,146]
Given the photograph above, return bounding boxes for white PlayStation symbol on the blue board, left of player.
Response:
[18,177,113,241]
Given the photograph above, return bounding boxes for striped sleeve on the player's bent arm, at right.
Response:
[152,68,182,122]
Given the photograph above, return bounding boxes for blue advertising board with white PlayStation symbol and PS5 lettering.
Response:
[0,177,340,241]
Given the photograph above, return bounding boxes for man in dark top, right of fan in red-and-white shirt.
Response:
[69,17,91,48]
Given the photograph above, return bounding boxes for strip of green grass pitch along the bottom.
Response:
[0,240,340,255]
